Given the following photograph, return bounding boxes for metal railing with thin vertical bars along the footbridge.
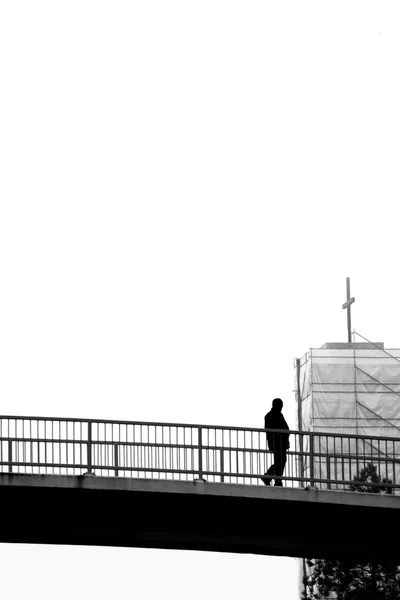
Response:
[0,416,400,493]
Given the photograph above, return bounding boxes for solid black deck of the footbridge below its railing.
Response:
[0,474,400,564]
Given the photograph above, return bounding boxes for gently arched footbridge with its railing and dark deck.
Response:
[0,417,400,564]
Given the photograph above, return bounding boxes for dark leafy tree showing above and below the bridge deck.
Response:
[302,463,400,600]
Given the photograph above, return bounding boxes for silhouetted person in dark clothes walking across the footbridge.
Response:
[261,398,289,485]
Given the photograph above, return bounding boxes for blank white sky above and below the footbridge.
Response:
[0,0,400,600]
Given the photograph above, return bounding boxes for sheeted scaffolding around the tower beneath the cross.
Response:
[295,332,400,489]
